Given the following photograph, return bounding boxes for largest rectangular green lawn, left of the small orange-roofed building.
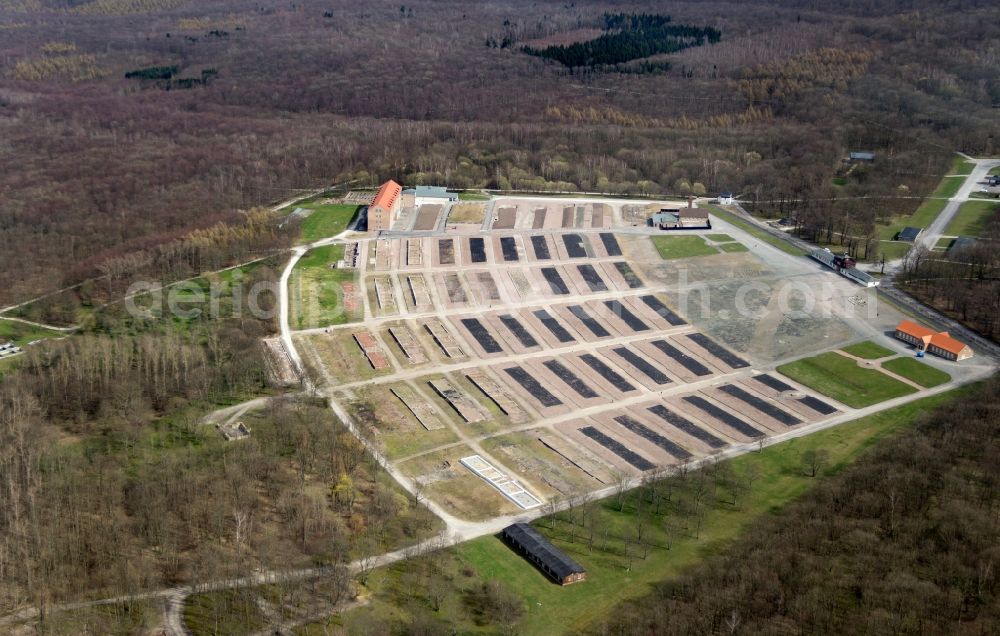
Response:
[778,351,916,408]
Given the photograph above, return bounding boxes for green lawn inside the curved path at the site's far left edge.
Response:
[288,245,362,329]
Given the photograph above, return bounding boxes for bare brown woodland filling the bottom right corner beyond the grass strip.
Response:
[598,380,1000,635]
